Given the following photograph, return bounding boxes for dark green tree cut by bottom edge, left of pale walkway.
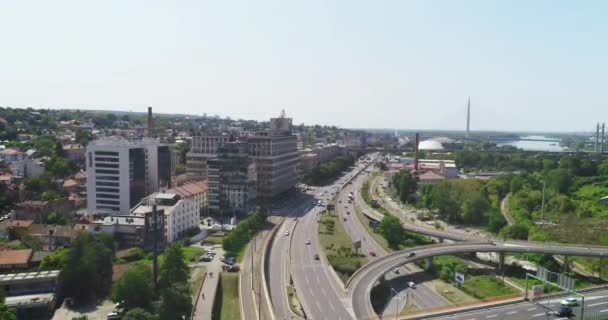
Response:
[158,282,192,319]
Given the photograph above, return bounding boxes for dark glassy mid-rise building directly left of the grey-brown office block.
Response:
[207,141,257,217]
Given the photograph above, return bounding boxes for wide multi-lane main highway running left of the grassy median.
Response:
[267,158,376,319]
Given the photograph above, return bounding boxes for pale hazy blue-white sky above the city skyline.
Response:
[0,0,608,131]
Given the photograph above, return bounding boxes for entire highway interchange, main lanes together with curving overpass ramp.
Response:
[267,154,608,319]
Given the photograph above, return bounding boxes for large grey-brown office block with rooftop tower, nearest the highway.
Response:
[247,112,300,205]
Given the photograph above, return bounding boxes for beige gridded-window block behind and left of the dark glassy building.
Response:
[186,134,230,179]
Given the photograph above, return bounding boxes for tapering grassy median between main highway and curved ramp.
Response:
[318,201,367,282]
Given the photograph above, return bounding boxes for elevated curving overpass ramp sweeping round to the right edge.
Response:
[347,241,608,319]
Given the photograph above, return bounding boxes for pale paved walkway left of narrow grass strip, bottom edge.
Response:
[192,248,224,320]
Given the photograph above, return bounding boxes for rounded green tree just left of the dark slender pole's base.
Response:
[112,263,154,309]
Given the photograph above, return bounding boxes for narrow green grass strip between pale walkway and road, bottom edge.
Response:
[213,272,241,320]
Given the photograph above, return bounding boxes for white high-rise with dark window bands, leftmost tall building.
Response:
[86,139,174,215]
